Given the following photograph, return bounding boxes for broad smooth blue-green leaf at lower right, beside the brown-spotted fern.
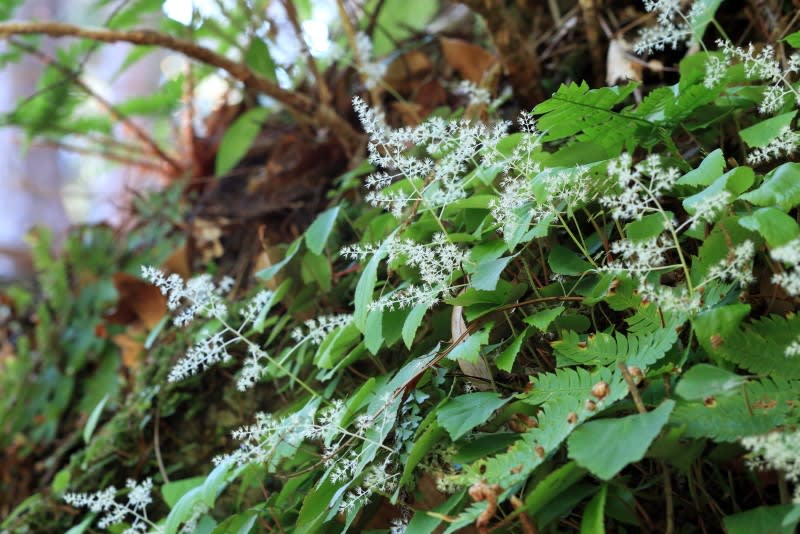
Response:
[567,400,675,480]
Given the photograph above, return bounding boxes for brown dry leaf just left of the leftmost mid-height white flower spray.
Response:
[108,272,167,329]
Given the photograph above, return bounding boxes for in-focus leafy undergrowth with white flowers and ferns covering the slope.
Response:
[1,2,800,533]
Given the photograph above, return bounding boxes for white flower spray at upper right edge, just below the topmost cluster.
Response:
[704,39,800,114]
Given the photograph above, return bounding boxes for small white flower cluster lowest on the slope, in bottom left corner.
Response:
[64,478,158,534]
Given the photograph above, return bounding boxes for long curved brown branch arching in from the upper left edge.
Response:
[0,21,361,148]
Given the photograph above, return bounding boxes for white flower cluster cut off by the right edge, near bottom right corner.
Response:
[742,430,800,504]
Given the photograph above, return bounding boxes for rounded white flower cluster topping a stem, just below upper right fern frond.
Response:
[600,153,680,220]
